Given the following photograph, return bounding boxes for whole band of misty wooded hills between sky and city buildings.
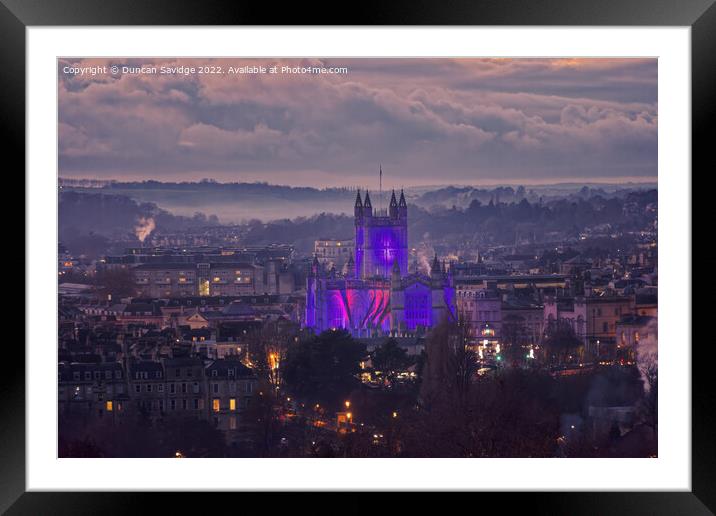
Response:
[59,181,658,255]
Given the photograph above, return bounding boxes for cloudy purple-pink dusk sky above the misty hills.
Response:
[58,58,658,187]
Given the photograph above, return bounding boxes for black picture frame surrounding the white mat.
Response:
[0,0,716,515]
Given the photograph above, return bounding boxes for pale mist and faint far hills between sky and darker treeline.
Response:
[60,179,656,224]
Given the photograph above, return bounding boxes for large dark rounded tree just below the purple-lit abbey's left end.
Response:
[282,330,366,408]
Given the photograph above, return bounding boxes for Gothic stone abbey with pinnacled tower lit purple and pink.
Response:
[305,187,455,337]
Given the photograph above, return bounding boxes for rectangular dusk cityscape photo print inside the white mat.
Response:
[57,58,658,459]
